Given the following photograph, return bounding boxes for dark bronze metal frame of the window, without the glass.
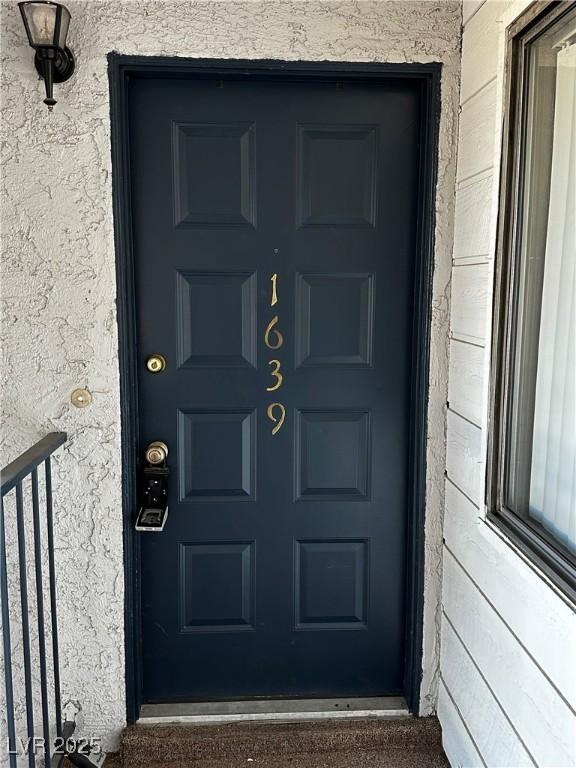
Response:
[485,0,576,603]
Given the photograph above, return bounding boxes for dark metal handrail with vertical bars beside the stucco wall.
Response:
[0,432,68,768]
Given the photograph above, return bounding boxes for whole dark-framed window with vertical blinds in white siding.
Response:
[487,2,576,597]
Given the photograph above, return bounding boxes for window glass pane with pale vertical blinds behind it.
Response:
[504,8,576,553]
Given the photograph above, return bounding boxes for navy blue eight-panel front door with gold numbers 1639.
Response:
[129,73,421,701]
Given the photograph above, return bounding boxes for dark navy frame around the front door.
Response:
[108,53,442,723]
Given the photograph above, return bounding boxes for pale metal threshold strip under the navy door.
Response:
[137,696,410,725]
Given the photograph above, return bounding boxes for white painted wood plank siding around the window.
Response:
[438,0,576,768]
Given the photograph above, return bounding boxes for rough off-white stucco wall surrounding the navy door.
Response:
[1,0,461,744]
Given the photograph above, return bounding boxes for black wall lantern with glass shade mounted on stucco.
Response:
[18,0,75,111]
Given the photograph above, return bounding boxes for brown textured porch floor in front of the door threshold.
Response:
[105,717,449,768]
